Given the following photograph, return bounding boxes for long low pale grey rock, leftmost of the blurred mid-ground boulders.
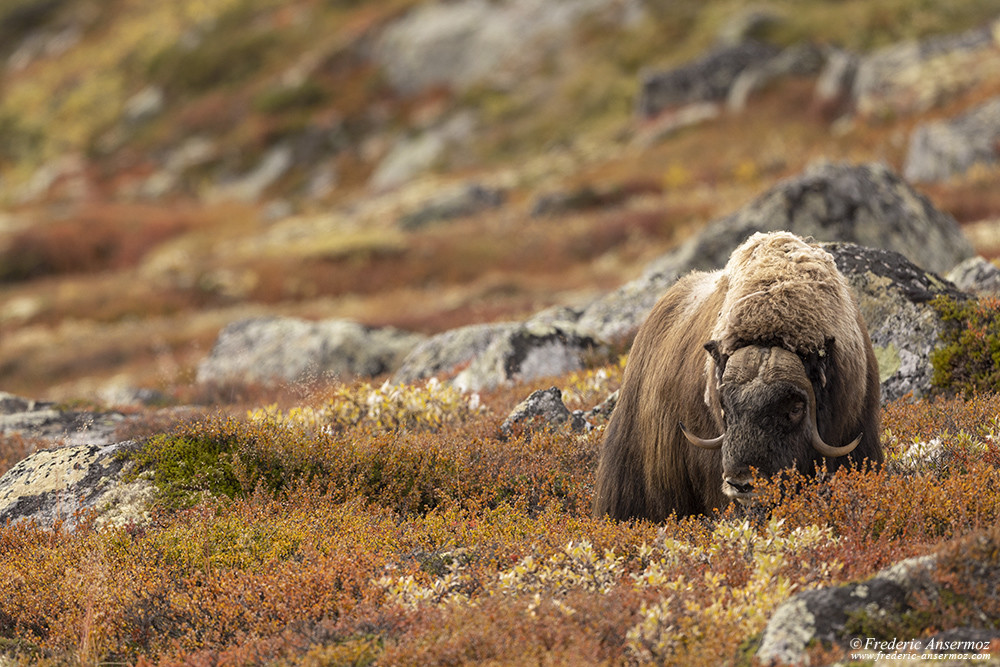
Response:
[197,317,424,383]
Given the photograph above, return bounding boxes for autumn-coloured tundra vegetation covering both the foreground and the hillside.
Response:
[0,0,1000,666]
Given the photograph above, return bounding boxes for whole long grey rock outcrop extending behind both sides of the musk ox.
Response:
[384,164,972,400]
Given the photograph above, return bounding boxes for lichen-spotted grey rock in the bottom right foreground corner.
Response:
[756,556,936,665]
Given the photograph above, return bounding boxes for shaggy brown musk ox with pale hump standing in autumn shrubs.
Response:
[594,232,882,521]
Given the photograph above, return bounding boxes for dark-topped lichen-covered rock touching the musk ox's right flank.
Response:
[824,243,968,403]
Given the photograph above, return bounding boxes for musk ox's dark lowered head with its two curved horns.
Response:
[680,343,861,502]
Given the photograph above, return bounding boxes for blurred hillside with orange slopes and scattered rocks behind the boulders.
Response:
[0,0,1000,400]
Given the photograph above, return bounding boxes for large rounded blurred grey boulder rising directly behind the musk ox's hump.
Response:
[646,164,973,275]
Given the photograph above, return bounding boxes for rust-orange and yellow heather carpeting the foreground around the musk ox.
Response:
[0,374,1000,665]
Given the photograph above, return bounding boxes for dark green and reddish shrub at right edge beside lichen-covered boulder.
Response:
[930,296,1000,397]
